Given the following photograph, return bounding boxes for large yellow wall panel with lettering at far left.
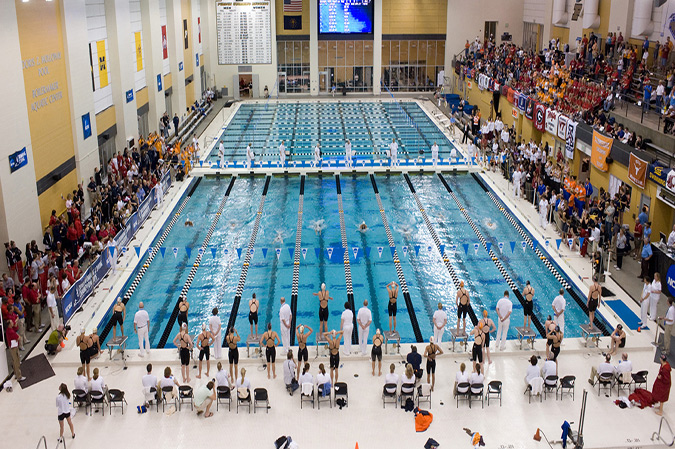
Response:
[16,0,75,180]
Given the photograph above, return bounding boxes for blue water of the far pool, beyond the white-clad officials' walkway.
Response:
[208,101,452,162]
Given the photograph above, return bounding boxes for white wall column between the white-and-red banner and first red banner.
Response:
[141,0,165,132]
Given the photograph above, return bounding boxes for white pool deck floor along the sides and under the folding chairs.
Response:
[0,96,675,449]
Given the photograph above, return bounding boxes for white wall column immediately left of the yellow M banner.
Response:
[61,0,101,201]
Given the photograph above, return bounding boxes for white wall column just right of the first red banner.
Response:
[166,0,185,117]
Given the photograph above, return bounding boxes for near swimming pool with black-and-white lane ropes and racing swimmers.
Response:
[101,174,608,348]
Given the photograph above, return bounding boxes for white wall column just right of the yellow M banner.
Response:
[105,0,138,152]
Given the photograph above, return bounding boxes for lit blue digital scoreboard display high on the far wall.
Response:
[319,0,374,34]
